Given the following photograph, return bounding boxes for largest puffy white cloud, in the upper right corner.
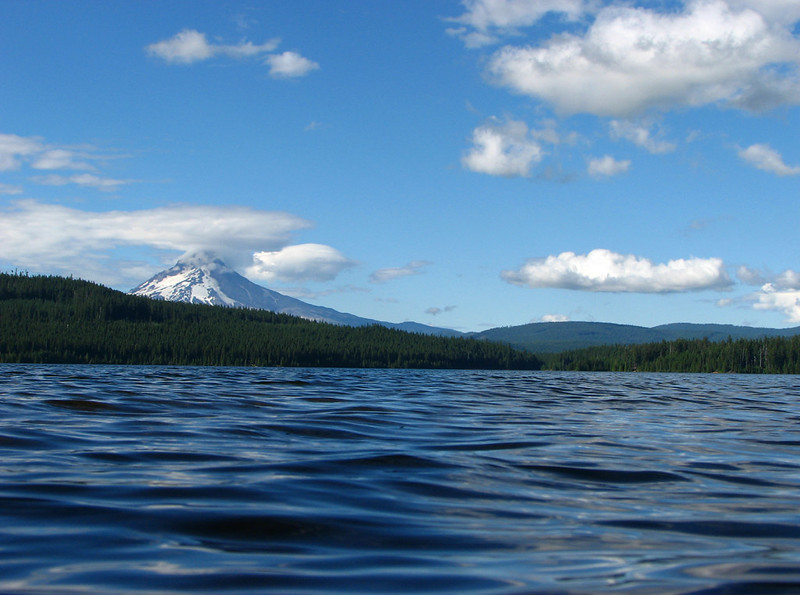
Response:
[488,0,800,117]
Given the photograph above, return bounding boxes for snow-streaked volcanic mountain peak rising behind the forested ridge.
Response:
[129,254,462,337]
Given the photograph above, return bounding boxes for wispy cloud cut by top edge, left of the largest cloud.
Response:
[448,0,585,47]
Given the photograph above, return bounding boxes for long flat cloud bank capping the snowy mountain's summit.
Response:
[0,200,311,284]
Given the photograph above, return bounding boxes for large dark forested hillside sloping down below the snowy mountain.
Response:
[0,273,540,369]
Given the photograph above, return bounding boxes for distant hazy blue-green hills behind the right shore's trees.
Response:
[470,322,800,353]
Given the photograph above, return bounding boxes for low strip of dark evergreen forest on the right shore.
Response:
[543,335,800,374]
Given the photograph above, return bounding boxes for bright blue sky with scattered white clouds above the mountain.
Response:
[0,0,800,331]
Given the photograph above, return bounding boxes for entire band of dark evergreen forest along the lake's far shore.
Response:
[0,273,800,374]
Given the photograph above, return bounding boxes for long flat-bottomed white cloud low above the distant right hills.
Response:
[501,249,731,293]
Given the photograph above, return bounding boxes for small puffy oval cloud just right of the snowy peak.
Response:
[246,244,356,281]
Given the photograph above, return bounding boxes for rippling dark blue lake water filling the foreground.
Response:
[0,365,800,594]
